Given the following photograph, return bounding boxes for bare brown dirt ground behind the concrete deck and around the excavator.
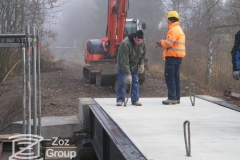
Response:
[0,61,238,129]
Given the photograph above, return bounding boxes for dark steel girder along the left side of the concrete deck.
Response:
[89,105,147,160]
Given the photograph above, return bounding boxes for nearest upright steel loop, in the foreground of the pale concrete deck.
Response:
[183,120,191,157]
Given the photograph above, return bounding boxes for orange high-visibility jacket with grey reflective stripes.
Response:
[161,22,186,59]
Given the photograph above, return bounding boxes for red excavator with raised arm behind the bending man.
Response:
[83,0,148,90]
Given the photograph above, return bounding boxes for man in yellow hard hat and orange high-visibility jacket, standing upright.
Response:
[157,11,186,105]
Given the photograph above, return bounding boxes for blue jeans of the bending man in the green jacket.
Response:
[117,68,140,103]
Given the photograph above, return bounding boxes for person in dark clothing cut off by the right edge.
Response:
[231,30,240,80]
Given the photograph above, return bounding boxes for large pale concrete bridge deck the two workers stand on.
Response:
[94,97,240,160]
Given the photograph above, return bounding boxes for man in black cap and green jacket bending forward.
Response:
[117,30,146,106]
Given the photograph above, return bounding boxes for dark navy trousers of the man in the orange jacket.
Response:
[164,57,182,100]
